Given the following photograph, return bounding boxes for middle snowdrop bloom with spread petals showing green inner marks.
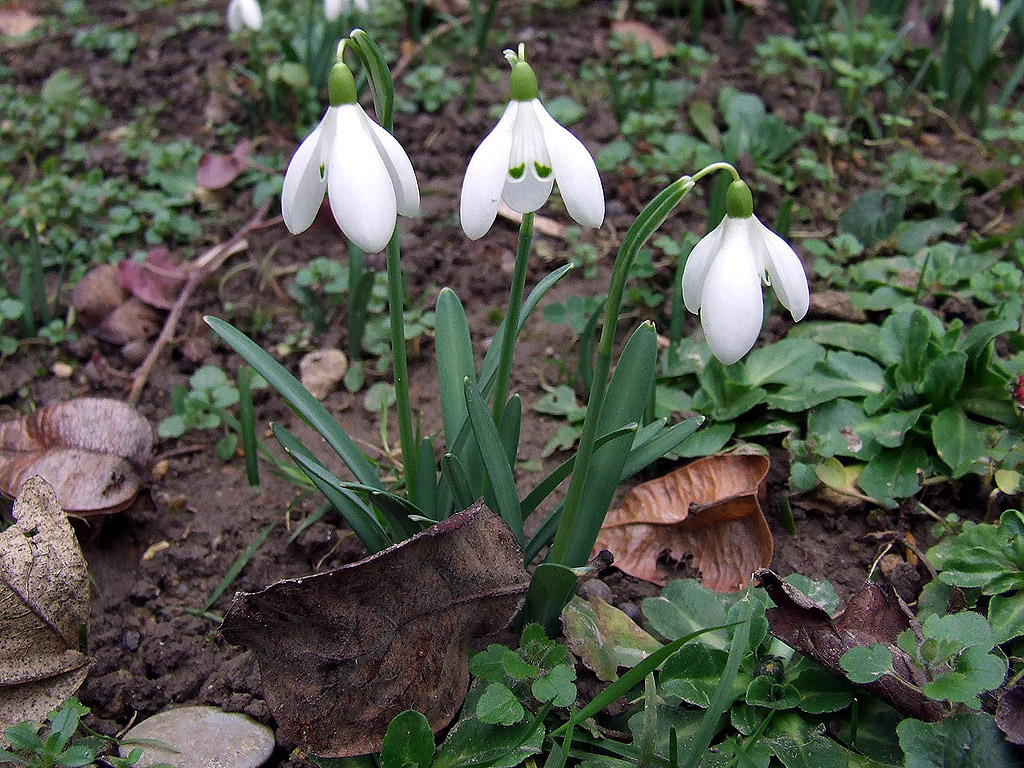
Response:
[460,44,604,240]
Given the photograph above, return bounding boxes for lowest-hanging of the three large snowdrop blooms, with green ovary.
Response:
[683,181,810,365]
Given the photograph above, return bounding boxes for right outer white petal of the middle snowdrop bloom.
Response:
[531,99,604,226]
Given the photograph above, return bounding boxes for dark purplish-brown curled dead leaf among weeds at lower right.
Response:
[754,568,944,721]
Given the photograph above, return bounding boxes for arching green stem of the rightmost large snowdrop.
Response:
[547,177,696,566]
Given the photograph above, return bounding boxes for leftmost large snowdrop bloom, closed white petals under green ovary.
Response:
[281,62,420,253]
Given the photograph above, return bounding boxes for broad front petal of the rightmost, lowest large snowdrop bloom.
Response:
[700,226,764,366]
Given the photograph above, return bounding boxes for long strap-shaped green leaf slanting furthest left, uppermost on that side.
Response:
[204,315,384,490]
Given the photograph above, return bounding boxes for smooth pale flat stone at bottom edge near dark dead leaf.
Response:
[120,707,274,768]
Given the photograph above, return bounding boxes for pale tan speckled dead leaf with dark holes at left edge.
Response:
[0,477,90,733]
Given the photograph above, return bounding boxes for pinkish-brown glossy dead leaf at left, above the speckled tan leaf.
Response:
[0,397,153,516]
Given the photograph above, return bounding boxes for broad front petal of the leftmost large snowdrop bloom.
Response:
[327,104,397,253]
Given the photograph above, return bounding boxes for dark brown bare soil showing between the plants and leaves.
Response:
[0,0,1015,767]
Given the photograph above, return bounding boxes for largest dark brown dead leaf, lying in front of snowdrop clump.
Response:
[221,502,529,757]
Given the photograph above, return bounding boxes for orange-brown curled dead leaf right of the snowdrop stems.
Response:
[594,456,774,592]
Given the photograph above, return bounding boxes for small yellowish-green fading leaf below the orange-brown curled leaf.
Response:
[562,595,662,683]
